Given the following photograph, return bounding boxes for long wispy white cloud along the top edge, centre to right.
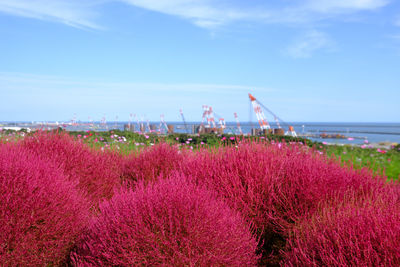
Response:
[119,0,389,28]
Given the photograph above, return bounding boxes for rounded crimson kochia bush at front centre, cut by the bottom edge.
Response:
[71,177,257,266]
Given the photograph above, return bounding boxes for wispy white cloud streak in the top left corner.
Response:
[0,0,102,29]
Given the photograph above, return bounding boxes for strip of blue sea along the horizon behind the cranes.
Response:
[0,121,400,144]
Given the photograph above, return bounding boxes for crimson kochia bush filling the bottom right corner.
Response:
[285,192,400,266]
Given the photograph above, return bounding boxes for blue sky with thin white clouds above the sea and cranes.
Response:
[0,0,400,122]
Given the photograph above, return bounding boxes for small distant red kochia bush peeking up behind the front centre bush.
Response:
[123,143,187,185]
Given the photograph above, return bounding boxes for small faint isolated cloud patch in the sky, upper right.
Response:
[285,31,333,58]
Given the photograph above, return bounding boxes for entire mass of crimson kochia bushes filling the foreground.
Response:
[0,132,400,266]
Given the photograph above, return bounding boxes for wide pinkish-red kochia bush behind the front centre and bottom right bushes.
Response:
[180,142,384,264]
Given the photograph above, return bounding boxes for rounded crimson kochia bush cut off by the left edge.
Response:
[0,144,88,266]
